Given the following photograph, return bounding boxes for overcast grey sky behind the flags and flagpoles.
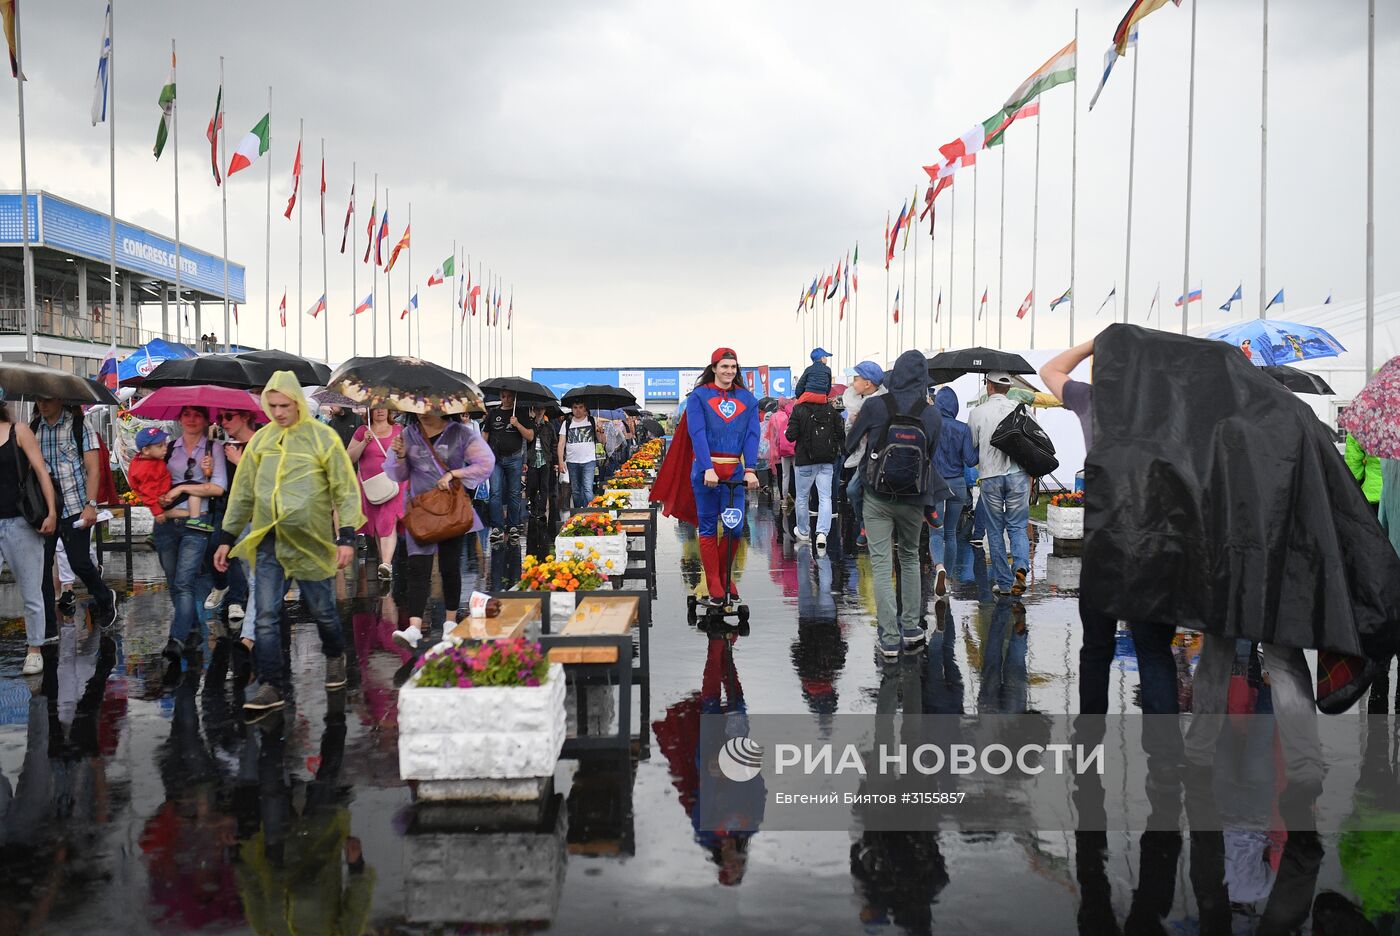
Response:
[0,0,1400,375]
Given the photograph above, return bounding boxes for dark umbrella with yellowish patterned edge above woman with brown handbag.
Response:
[326,357,484,413]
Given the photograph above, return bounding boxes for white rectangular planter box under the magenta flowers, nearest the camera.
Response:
[399,663,566,800]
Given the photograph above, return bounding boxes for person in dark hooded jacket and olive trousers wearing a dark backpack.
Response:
[846,350,948,660]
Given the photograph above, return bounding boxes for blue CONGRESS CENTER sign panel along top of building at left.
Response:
[0,193,246,302]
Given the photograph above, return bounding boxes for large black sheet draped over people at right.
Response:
[1081,325,1400,658]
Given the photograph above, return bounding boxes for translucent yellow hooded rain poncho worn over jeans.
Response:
[224,371,364,582]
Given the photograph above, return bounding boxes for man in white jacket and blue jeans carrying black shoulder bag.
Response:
[967,371,1030,595]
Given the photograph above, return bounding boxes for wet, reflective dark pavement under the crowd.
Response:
[0,504,1383,933]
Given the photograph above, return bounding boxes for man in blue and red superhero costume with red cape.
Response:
[651,348,759,607]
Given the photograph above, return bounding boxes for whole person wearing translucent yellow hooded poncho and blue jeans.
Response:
[214,371,364,714]
